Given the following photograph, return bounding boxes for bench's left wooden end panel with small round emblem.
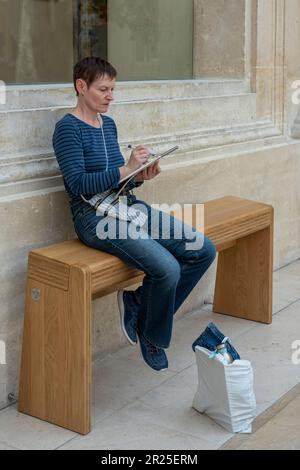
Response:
[19,266,91,434]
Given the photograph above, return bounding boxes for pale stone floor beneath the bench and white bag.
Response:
[0,260,300,450]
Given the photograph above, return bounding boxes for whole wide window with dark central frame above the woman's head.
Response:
[0,0,193,83]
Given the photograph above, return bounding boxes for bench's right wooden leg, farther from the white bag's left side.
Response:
[213,226,273,323]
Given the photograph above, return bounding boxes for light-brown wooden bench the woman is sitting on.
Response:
[19,196,273,434]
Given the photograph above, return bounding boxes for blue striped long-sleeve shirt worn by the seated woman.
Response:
[53,114,139,201]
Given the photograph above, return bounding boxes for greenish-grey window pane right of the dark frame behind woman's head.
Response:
[108,0,194,80]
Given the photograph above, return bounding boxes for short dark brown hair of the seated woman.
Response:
[73,57,117,96]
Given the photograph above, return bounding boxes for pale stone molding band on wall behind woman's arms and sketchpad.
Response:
[0,120,283,198]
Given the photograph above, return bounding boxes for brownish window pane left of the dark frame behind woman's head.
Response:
[0,0,73,83]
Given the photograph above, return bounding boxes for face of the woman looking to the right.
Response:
[82,75,116,113]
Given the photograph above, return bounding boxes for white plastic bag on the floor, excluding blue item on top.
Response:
[193,346,256,433]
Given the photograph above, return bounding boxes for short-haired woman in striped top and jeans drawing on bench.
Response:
[53,57,216,371]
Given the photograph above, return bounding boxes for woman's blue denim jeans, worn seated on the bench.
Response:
[71,196,216,348]
